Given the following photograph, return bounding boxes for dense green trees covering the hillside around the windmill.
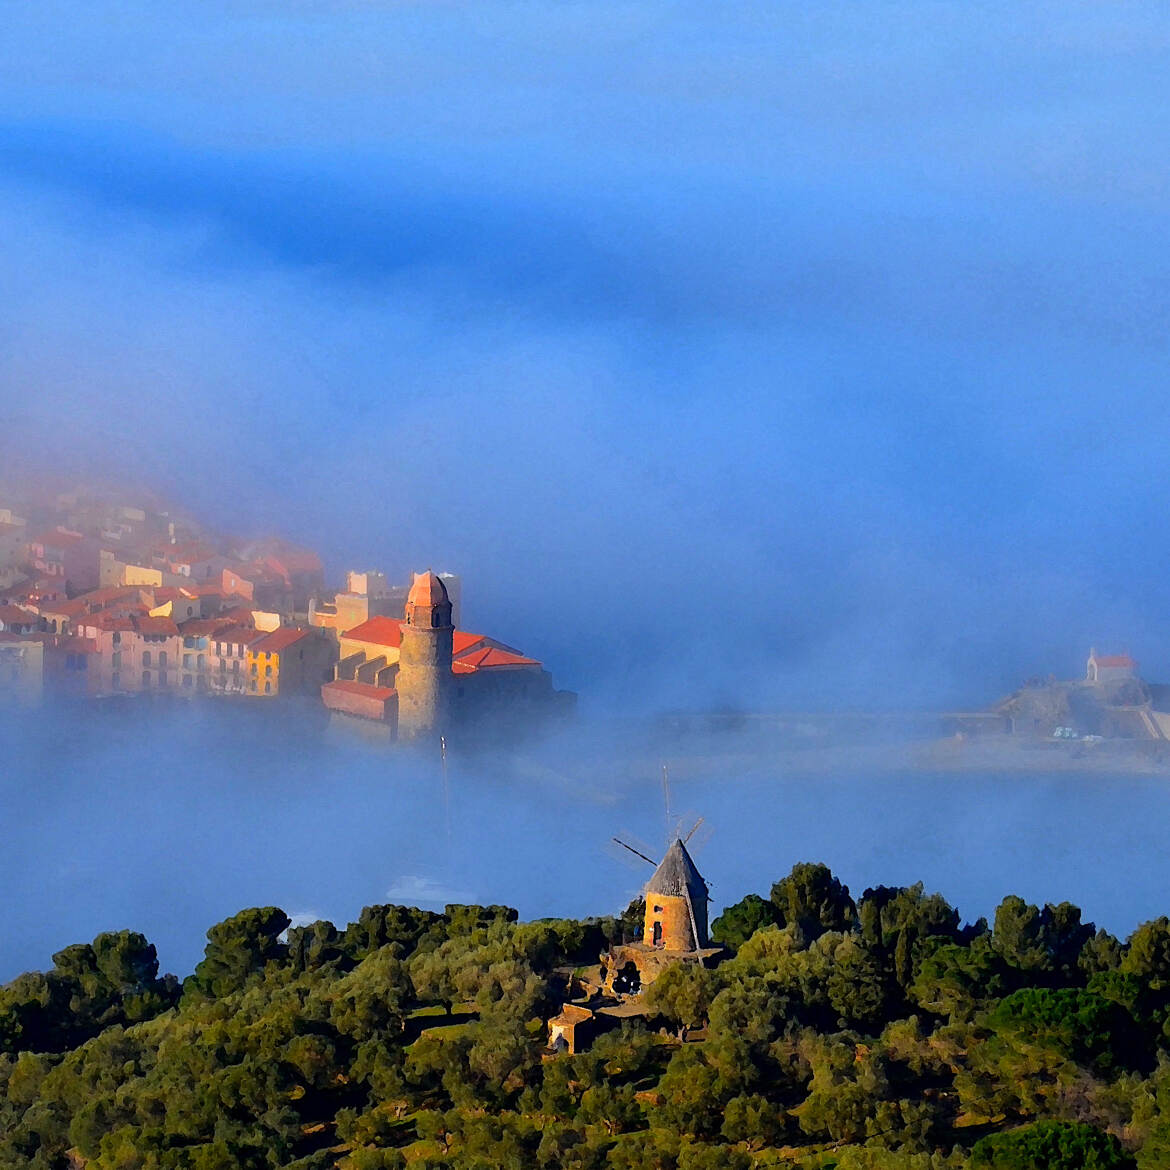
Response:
[0,865,1170,1170]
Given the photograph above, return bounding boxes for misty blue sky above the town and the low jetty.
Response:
[0,2,1170,708]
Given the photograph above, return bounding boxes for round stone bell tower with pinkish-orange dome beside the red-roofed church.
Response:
[394,570,454,739]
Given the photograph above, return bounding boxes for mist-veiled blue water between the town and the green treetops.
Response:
[0,703,1170,979]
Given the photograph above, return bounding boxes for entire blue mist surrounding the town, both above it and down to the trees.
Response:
[0,0,1170,977]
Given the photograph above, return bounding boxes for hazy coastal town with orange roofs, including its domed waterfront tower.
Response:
[0,489,576,739]
